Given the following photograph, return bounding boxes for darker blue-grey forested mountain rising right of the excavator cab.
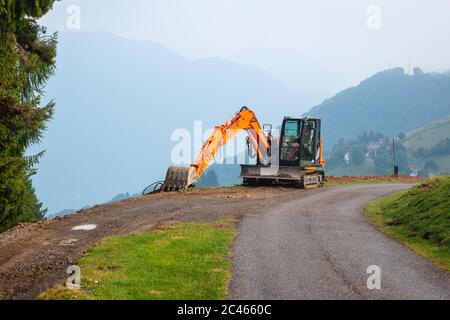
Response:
[308,68,450,147]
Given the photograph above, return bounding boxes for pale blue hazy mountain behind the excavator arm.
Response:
[30,33,306,213]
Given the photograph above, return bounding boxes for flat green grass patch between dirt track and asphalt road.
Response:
[38,220,236,300]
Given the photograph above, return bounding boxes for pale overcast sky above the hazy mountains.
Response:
[42,0,450,92]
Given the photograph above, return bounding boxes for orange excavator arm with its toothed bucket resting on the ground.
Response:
[164,107,270,191]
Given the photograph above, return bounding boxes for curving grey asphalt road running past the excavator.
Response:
[229,185,450,299]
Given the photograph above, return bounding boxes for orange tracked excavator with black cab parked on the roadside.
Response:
[162,107,325,191]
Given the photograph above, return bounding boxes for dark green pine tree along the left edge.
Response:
[0,0,56,231]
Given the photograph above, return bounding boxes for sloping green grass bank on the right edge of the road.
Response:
[365,178,450,271]
